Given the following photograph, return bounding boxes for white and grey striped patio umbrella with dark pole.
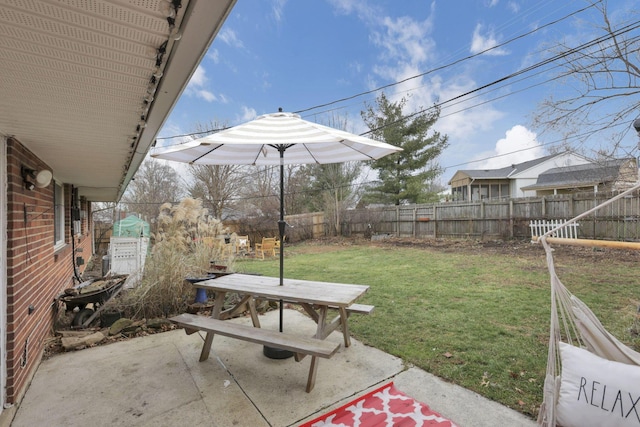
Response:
[151,109,401,354]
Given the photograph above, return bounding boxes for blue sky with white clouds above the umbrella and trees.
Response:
[157,0,636,185]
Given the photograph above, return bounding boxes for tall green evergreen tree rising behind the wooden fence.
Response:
[361,93,449,205]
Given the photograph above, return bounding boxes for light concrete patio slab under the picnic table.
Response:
[11,310,536,427]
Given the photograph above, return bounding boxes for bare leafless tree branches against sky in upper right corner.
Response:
[533,0,640,156]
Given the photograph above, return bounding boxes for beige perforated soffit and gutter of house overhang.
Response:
[0,0,236,201]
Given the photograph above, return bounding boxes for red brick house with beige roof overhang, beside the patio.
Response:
[0,0,235,425]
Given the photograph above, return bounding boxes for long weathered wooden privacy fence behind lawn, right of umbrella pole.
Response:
[342,193,640,241]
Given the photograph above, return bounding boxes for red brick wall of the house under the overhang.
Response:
[7,138,91,403]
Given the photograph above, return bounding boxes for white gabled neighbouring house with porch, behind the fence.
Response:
[449,151,590,201]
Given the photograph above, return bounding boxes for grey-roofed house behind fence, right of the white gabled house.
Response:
[522,158,638,196]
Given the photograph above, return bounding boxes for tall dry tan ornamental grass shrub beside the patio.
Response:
[121,198,232,318]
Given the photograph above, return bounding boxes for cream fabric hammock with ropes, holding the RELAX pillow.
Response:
[538,183,640,427]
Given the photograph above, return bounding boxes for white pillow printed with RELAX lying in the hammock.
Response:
[556,342,640,427]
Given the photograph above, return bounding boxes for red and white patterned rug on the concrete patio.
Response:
[300,383,456,427]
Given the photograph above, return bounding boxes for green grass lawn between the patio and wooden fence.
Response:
[235,242,640,418]
